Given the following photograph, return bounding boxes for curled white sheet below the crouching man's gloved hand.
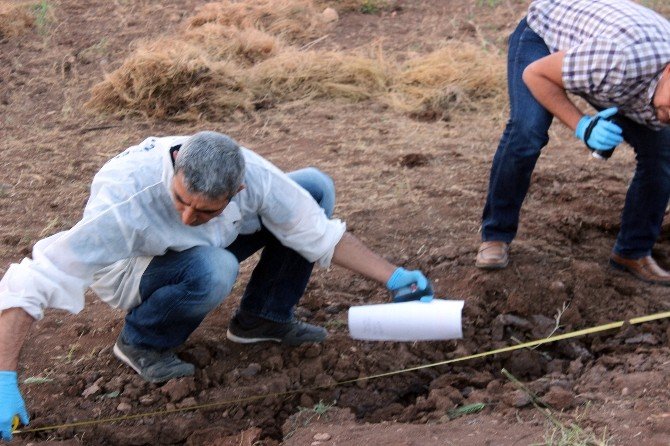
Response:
[349,299,463,341]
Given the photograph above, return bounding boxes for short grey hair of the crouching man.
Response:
[174,132,244,199]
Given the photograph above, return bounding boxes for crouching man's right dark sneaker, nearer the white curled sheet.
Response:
[226,316,328,345]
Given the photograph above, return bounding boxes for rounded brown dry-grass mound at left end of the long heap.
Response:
[89,40,251,120]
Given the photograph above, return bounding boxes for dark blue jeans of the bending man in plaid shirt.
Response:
[482,19,670,258]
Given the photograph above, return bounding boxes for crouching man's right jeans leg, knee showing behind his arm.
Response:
[227,168,335,322]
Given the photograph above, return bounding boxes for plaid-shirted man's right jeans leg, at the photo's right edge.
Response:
[614,118,670,259]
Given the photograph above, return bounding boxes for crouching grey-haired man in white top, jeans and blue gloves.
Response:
[0,132,432,440]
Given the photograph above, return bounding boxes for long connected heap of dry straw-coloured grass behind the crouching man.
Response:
[87,0,505,120]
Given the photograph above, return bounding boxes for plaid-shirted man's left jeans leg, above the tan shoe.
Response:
[482,19,553,243]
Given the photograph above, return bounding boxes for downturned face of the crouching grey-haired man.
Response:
[172,172,230,226]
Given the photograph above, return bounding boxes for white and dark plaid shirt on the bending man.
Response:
[527,0,670,129]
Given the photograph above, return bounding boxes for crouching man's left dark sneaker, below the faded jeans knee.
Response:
[114,335,195,383]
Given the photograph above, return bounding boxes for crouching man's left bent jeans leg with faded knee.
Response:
[122,246,239,351]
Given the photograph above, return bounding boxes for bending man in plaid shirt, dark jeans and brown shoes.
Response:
[476,0,670,285]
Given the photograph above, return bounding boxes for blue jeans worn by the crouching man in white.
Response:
[122,168,335,351]
